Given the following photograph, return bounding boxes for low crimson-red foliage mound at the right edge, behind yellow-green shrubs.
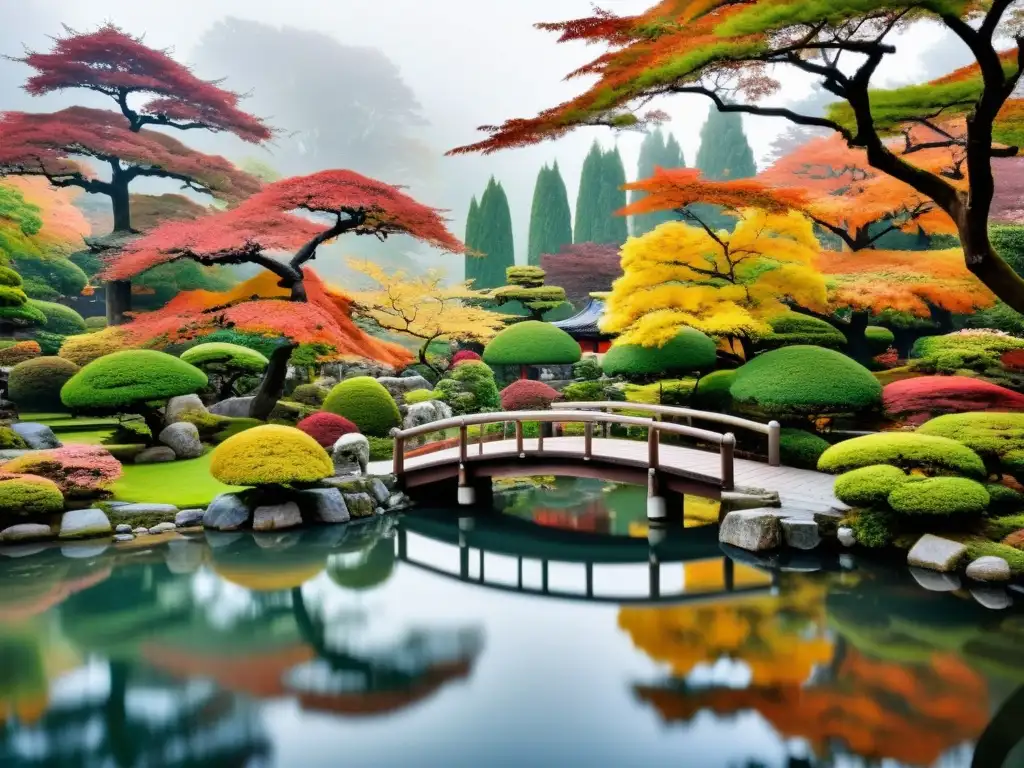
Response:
[882,376,1024,421]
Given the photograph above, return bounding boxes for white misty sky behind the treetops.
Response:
[0,0,967,278]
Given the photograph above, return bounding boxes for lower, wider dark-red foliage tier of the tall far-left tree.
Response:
[0,106,260,202]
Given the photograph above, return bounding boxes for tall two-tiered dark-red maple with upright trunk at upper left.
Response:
[0,24,271,324]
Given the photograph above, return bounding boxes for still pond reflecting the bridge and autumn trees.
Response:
[0,478,1024,768]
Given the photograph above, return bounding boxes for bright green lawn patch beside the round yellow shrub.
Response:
[113,453,242,509]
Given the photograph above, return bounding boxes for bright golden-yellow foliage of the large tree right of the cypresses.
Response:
[601,209,827,346]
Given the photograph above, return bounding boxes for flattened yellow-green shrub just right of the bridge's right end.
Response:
[818,432,987,478]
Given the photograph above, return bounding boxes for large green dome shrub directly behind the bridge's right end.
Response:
[729,345,882,416]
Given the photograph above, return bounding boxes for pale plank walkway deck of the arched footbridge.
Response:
[370,437,843,513]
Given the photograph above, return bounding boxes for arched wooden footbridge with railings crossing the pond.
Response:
[374,402,841,519]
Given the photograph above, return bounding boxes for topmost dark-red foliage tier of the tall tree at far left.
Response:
[18,24,271,143]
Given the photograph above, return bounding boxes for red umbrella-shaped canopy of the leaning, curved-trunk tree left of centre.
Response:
[103,170,465,280]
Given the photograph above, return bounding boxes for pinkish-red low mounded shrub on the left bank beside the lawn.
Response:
[0,444,121,499]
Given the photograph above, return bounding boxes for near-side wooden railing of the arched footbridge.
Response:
[391,403,736,490]
